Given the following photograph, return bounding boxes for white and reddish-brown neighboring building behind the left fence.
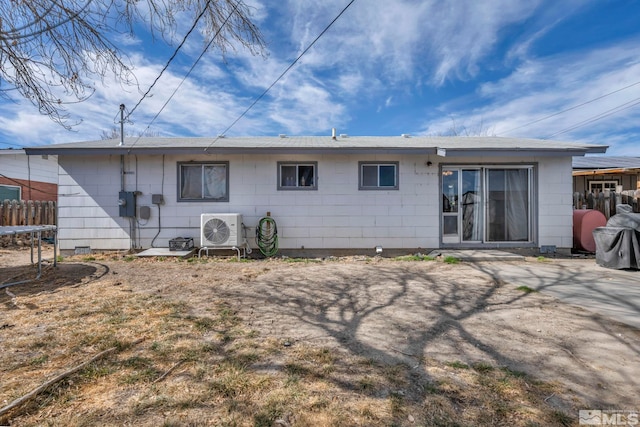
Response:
[0,149,58,201]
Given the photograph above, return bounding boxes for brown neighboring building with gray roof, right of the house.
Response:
[573,156,640,194]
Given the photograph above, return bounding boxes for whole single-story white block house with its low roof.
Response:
[26,135,607,253]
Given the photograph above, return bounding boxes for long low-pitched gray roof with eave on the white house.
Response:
[25,135,608,157]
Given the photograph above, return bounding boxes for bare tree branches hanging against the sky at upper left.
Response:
[0,0,265,129]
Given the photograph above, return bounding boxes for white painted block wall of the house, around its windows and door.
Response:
[58,155,573,254]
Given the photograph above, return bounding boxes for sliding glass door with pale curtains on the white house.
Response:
[441,166,533,244]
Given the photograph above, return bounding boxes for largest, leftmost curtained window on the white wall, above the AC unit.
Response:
[178,162,229,202]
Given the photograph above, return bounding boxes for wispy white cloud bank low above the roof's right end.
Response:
[424,40,640,150]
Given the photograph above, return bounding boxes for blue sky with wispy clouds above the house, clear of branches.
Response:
[0,0,640,156]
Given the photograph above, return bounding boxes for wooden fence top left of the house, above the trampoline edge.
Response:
[0,200,57,226]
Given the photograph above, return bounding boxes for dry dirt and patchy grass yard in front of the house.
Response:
[0,249,640,426]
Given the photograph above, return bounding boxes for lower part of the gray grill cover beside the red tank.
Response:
[593,226,640,270]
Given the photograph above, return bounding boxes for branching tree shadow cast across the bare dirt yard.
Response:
[214,263,584,409]
